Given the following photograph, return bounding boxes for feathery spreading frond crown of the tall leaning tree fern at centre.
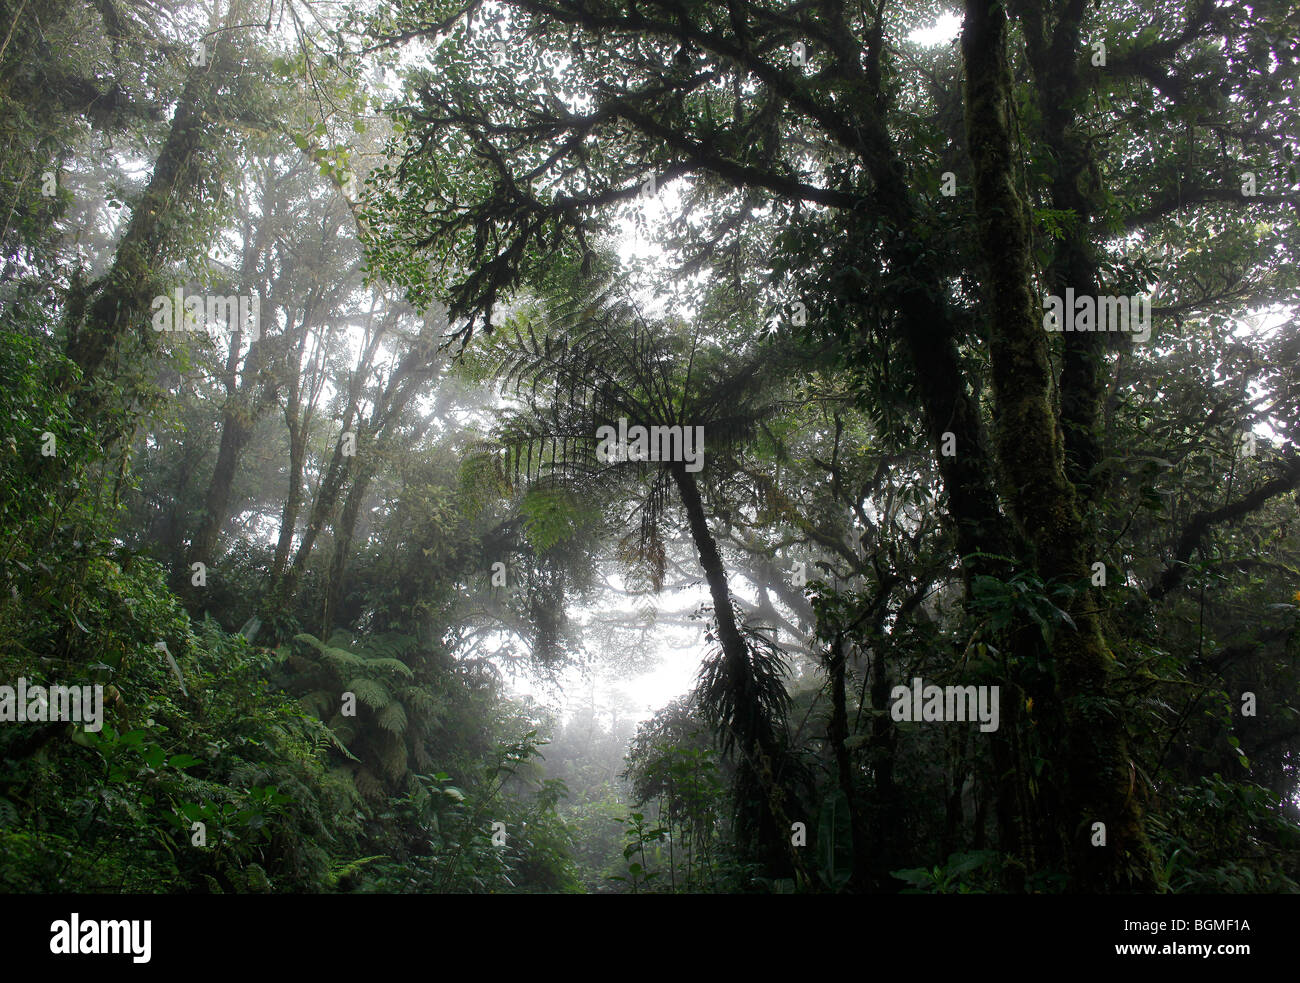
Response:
[475,273,777,605]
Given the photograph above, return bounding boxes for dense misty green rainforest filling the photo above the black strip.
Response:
[0,0,1300,893]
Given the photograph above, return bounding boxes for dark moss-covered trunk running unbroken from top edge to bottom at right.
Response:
[962,0,1154,892]
